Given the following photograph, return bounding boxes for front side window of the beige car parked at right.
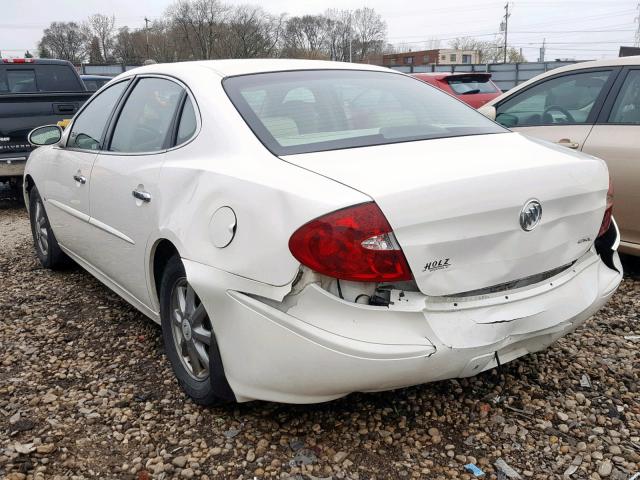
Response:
[496,71,611,127]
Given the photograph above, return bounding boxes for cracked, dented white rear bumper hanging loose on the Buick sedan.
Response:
[187,249,622,403]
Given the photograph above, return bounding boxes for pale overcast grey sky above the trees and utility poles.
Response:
[0,0,638,61]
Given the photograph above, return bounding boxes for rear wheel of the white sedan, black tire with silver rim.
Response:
[160,256,235,405]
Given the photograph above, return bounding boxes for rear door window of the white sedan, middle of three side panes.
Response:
[109,78,184,153]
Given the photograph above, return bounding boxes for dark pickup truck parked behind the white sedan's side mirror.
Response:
[0,58,92,193]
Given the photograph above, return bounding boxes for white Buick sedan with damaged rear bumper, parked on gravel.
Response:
[24,60,622,404]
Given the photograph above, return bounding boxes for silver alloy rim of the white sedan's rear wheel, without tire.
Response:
[170,278,211,381]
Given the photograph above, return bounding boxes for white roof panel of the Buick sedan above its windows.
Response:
[121,58,400,77]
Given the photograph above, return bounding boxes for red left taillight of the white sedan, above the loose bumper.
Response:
[289,202,413,282]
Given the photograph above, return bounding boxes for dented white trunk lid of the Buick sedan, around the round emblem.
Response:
[283,133,608,296]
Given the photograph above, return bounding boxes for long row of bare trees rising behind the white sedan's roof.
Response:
[39,0,388,64]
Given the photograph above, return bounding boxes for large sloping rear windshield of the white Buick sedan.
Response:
[223,70,506,155]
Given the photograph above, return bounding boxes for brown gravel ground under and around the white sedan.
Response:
[0,192,640,480]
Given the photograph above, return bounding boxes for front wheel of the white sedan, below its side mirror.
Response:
[29,187,69,270]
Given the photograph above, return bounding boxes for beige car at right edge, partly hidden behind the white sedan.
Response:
[481,57,640,255]
